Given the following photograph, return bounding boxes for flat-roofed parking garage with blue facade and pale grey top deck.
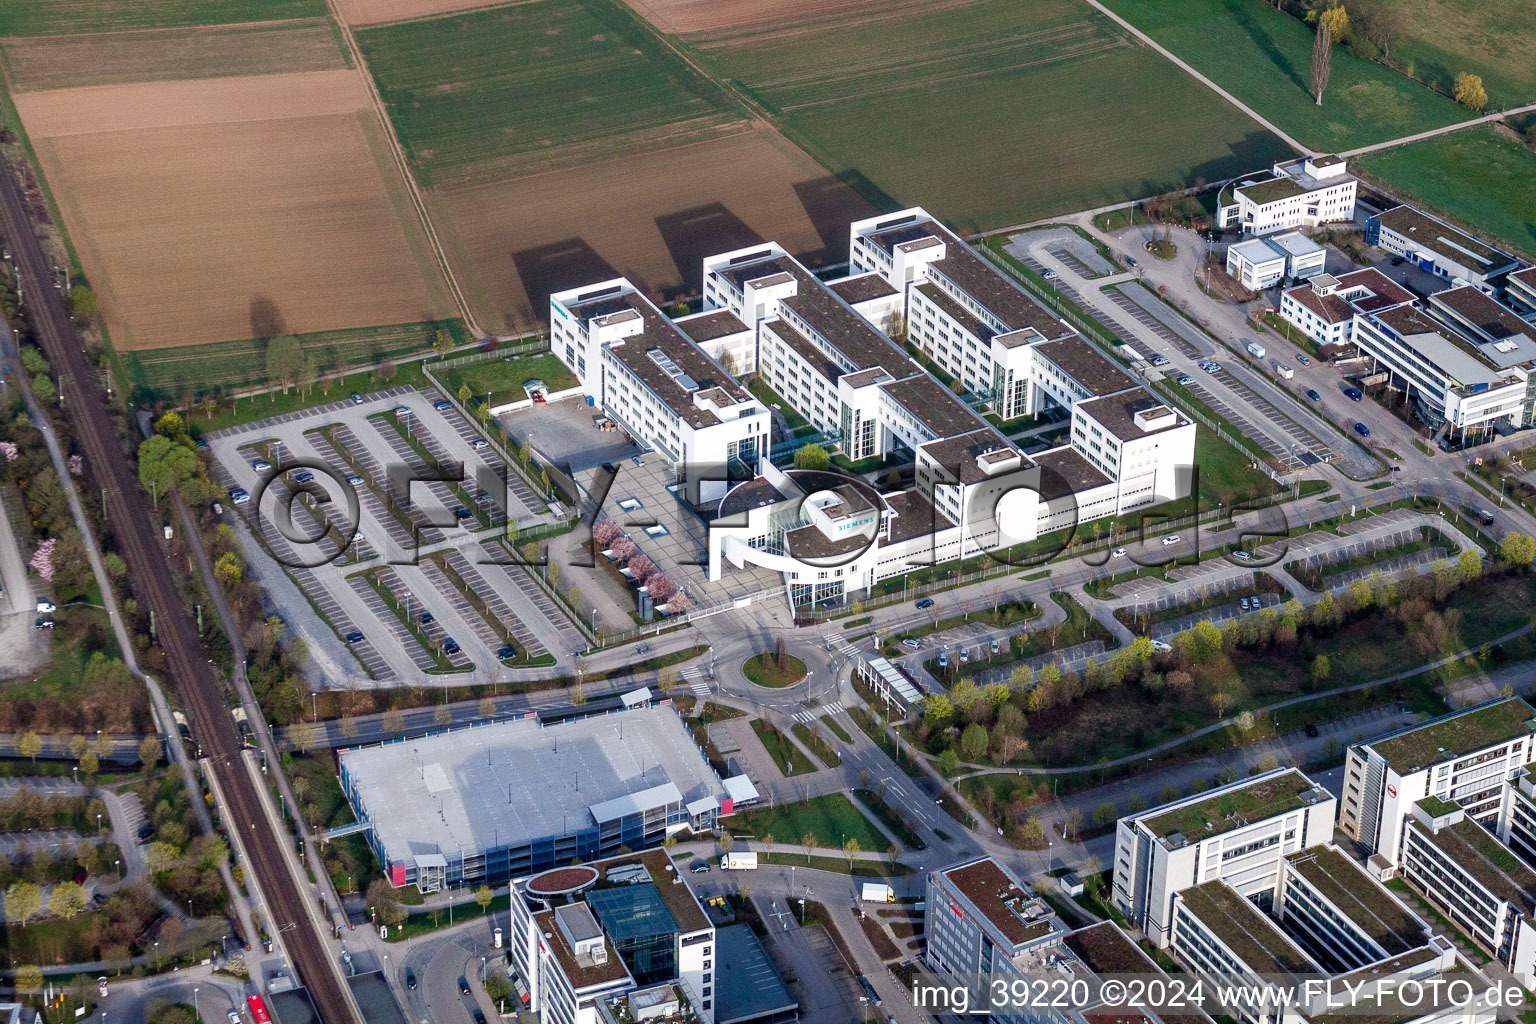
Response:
[339,703,731,892]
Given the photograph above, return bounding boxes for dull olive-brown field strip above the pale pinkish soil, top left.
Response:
[0,18,347,92]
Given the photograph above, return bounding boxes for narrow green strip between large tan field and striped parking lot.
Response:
[121,319,468,401]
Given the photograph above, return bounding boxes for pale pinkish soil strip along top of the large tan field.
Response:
[14,71,369,138]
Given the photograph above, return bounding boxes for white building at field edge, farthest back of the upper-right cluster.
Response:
[1217,157,1356,235]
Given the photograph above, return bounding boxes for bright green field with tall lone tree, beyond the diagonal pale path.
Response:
[1106,0,1471,152]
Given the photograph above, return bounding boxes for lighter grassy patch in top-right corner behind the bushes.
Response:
[1390,0,1536,111]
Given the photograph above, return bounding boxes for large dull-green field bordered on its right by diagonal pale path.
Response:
[690,0,1289,230]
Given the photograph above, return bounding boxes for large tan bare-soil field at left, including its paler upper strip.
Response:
[15,71,456,350]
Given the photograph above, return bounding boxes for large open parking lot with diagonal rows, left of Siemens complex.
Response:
[204,388,585,686]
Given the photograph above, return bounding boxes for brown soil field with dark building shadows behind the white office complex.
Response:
[429,124,872,332]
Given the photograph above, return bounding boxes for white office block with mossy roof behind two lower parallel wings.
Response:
[1114,768,1336,947]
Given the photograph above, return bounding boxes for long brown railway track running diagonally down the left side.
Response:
[0,154,361,1024]
